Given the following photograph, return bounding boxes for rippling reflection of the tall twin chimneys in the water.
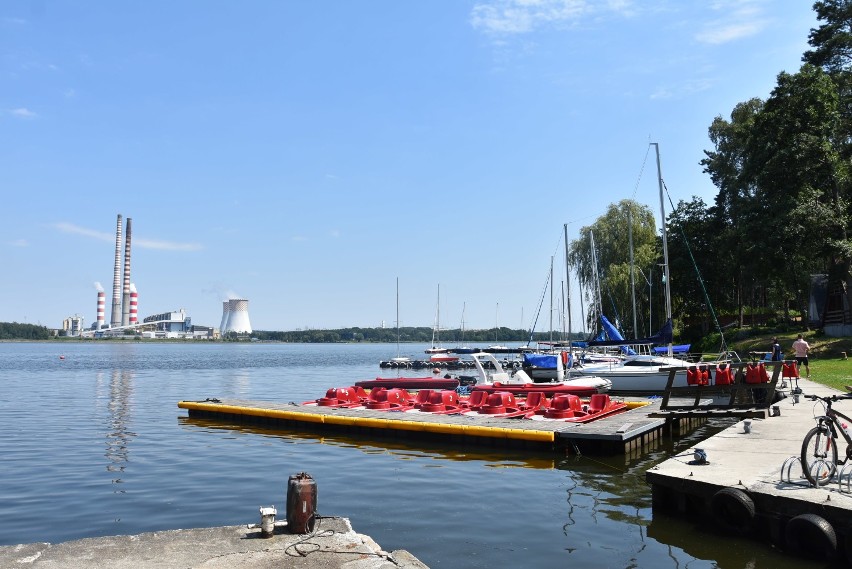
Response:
[96,369,136,494]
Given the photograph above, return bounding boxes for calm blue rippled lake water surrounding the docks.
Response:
[0,342,836,569]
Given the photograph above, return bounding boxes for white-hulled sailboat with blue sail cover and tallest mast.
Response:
[575,142,694,393]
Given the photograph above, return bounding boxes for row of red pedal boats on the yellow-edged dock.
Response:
[303,386,628,423]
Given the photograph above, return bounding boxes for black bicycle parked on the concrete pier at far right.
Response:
[802,394,852,488]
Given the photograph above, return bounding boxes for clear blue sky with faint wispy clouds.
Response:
[0,0,817,330]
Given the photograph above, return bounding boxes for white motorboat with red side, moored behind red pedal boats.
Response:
[471,352,611,397]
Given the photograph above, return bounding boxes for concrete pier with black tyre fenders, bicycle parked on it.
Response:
[645,379,852,562]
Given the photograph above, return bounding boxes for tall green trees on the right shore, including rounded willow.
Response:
[569,0,852,341]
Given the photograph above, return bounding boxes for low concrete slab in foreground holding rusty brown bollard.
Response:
[0,518,428,569]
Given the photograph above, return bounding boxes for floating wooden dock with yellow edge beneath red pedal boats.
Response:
[178,398,704,454]
